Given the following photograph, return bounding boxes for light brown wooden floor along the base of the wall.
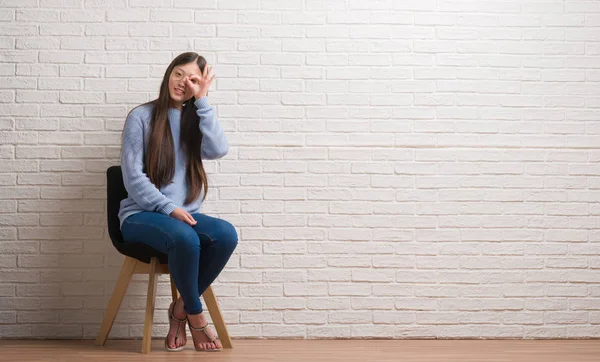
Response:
[0,340,600,362]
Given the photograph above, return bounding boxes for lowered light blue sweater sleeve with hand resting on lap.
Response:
[121,109,177,215]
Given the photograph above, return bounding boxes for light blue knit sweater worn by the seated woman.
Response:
[119,97,229,227]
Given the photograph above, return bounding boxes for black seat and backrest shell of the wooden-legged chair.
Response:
[106,166,168,264]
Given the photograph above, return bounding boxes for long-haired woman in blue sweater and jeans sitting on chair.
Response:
[119,52,238,351]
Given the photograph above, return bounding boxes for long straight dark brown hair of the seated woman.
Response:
[145,52,208,204]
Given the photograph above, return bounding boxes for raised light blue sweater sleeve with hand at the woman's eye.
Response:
[194,97,229,160]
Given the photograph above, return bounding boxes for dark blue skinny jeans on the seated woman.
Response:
[121,211,238,314]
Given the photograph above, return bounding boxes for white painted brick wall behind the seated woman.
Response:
[0,0,600,338]
